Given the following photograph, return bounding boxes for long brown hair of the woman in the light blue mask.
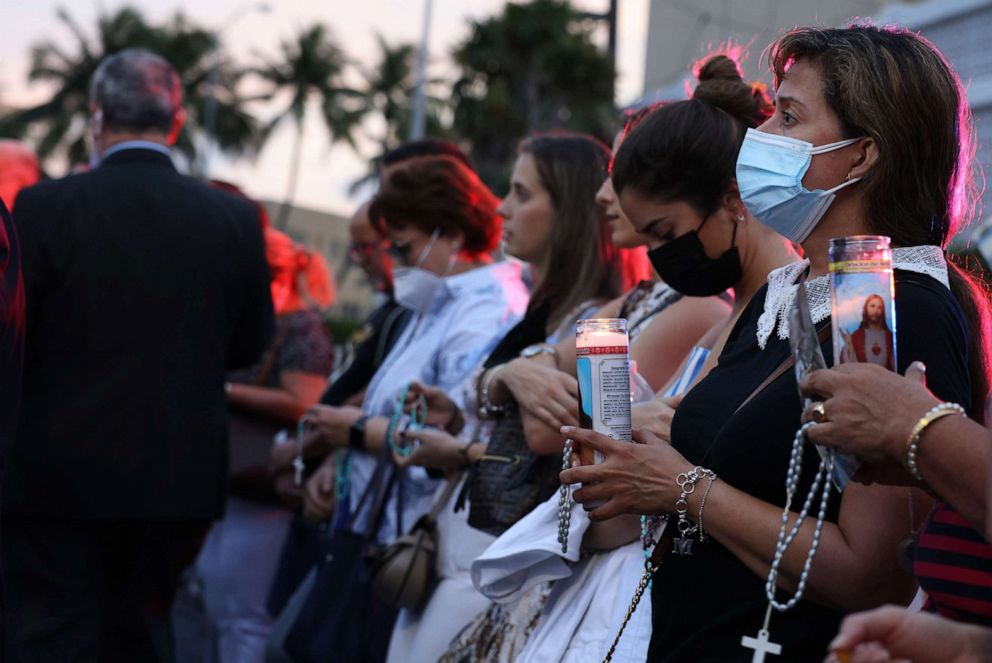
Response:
[770,24,992,421]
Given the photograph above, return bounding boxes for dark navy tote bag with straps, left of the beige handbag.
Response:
[284,446,402,663]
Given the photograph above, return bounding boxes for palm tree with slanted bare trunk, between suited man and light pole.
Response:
[256,23,366,228]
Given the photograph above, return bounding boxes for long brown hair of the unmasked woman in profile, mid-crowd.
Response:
[519,132,626,330]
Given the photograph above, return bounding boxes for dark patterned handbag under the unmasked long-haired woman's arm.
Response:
[468,407,561,536]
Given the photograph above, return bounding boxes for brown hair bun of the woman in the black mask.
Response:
[692,54,773,127]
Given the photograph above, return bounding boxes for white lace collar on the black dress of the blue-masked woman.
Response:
[757,246,950,350]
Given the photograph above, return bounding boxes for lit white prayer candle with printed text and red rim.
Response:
[575,318,630,510]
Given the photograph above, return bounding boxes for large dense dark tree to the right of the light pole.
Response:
[451,0,616,191]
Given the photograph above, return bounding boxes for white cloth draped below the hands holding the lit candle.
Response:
[472,494,651,663]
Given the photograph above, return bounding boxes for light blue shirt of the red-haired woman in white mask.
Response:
[349,262,529,543]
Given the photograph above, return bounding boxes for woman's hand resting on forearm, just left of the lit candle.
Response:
[493,358,579,430]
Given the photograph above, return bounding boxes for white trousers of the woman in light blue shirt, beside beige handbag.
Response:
[386,478,496,663]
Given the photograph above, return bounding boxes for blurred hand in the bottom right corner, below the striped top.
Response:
[827,606,992,663]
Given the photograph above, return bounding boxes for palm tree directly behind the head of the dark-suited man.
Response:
[0,7,258,171]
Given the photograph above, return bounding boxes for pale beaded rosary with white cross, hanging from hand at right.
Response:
[741,422,834,663]
